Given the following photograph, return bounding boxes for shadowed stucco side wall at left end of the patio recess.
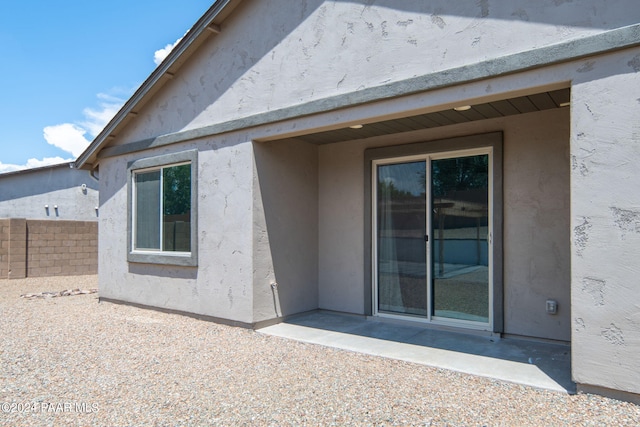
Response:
[254,141,318,317]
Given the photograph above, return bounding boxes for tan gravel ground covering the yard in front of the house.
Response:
[0,276,640,426]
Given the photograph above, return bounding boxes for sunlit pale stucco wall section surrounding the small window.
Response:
[99,136,253,323]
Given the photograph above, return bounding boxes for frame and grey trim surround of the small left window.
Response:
[127,150,198,266]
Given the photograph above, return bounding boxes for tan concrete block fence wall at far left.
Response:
[0,218,98,279]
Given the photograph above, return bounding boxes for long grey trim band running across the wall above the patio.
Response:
[96,20,640,159]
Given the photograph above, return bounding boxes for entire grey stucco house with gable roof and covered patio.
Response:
[77,0,640,397]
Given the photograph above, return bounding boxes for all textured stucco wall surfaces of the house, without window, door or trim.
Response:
[92,0,640,393]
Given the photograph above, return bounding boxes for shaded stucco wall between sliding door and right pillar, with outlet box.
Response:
[504,108,571,341]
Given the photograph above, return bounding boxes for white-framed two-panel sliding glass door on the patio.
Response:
[373,149,491,327]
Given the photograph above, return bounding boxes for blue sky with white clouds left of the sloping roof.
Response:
[0,0,213,173]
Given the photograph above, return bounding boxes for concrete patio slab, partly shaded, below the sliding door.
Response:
[258,311,575,393]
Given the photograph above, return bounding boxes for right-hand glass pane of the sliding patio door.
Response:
[430,154,489,323]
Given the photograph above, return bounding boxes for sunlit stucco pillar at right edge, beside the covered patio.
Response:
[571,49,640,393]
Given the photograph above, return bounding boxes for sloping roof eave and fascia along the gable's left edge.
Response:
[75,0,242,169]
